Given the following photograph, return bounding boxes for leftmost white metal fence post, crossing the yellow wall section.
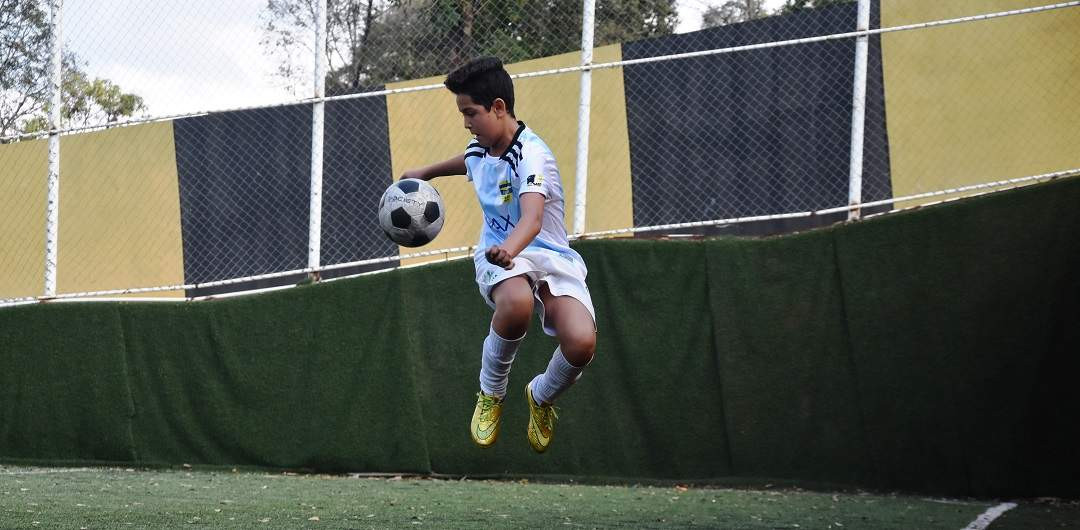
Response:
[45,0,64,297]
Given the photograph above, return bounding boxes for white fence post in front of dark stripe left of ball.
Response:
[308,0,326,278]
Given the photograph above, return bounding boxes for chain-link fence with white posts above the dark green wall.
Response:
[0,0,1080,302]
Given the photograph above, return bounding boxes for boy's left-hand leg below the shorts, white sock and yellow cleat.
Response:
[470,276,532,447]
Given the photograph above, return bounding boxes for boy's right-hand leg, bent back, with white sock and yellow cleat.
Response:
[525,285,596,452]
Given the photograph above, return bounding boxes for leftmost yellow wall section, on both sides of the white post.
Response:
[0,122,184,298]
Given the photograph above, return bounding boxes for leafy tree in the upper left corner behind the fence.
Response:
[0,0,146,136]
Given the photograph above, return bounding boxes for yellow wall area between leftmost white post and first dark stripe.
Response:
[56,122,184,297]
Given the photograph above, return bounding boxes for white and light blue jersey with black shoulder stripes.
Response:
[464,122,581,262]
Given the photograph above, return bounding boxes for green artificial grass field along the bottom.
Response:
[0,466,1080,529]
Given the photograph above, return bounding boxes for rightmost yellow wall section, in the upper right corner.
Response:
[881,0,1080,206]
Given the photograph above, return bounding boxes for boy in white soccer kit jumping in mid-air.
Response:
[402,57,596,452]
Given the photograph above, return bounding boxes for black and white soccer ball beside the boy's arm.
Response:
[379,178,446,246]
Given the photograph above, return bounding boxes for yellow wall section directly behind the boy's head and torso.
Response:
[387,44,633,263]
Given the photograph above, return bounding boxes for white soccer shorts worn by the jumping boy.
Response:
[473,247,596,337]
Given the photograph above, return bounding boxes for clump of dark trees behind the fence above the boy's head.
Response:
[261,0,678,94]
